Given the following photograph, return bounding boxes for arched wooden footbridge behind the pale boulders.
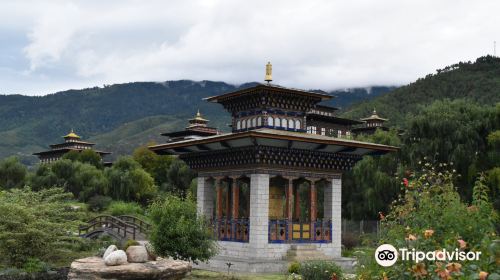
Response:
[78,215,151,242]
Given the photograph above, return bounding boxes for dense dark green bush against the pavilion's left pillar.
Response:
[149,195,217,263]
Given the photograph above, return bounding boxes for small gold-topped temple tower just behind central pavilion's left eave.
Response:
[161,110,220,142]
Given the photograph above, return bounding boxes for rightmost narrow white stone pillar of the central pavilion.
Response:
[331,175,342,257]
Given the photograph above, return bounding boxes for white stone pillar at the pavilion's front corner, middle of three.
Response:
[249,174,269,253]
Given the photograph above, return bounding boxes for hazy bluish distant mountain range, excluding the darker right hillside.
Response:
[0,80,386,163]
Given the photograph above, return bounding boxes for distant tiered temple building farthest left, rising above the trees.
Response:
[33,130,111,163]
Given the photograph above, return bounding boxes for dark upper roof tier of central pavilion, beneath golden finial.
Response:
[205,84,333,116]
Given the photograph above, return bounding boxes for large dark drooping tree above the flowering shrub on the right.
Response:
[402,100,500,200]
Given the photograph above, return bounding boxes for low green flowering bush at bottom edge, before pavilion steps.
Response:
[299,261,343,280]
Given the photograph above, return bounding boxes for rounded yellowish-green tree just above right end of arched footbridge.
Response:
[105,157,157,203]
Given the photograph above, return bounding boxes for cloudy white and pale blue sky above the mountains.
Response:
[0,0,500,95]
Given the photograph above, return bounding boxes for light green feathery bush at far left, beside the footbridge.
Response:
[0,187,84,268]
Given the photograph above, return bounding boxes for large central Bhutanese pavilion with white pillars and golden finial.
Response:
[150,64,398,272]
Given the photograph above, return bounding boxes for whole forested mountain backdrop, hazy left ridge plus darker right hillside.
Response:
[0,56,500,163]
